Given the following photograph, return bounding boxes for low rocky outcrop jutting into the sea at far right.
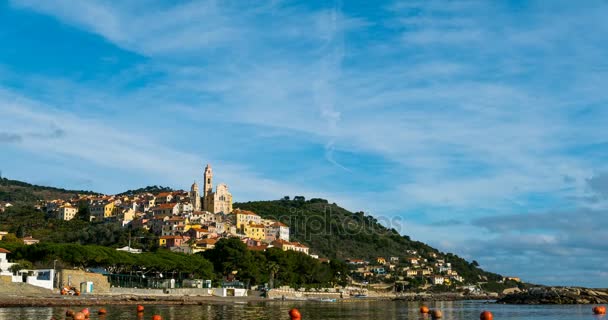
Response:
[496,287,608,304]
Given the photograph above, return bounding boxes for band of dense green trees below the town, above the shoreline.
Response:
[0,238,348,287]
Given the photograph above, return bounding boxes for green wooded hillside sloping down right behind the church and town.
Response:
[233,197,502,281]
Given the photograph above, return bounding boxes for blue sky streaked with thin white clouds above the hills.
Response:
[0,0,608,287]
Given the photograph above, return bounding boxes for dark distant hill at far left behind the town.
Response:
[0,178,98,204]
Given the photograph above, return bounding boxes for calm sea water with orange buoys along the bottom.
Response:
[0,300,608,320]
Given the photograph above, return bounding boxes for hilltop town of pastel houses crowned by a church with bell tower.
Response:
[34,164,308,257]
